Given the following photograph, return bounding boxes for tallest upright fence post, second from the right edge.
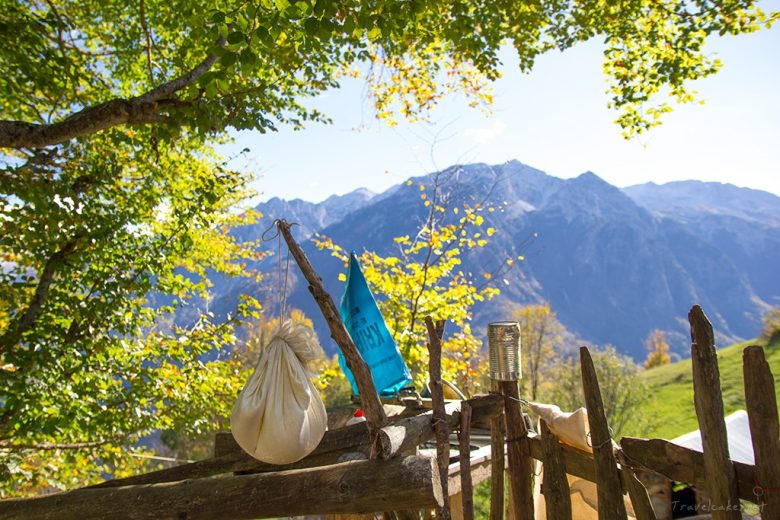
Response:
[688,305,742,520]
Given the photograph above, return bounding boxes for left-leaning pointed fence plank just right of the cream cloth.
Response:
[580,347,627,520]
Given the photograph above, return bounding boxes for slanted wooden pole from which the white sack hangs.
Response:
[277,220,387,434]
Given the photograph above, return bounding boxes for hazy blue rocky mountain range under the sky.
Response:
[212,161,780,359]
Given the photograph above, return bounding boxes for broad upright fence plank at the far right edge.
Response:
[742,346,780,518]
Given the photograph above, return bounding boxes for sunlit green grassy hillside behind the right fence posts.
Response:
[635,340,780,439]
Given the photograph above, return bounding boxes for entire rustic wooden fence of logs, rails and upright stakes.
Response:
[0,223,780,520]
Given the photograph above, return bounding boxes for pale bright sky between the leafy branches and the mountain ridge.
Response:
[222,14,780,202]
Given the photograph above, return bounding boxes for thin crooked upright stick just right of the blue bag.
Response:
[425,316,451,520]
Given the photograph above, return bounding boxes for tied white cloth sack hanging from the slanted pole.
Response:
[230,321,328,464]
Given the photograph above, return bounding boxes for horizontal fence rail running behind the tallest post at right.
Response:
[620,437,756,502]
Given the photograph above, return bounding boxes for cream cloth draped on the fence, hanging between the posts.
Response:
[529,403,634,520]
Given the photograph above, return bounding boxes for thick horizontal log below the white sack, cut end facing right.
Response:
[0,456,444,520]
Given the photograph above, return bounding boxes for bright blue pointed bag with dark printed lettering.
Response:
[339,252,412,396]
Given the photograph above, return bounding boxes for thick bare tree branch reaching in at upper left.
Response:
[0,38,225,148]
